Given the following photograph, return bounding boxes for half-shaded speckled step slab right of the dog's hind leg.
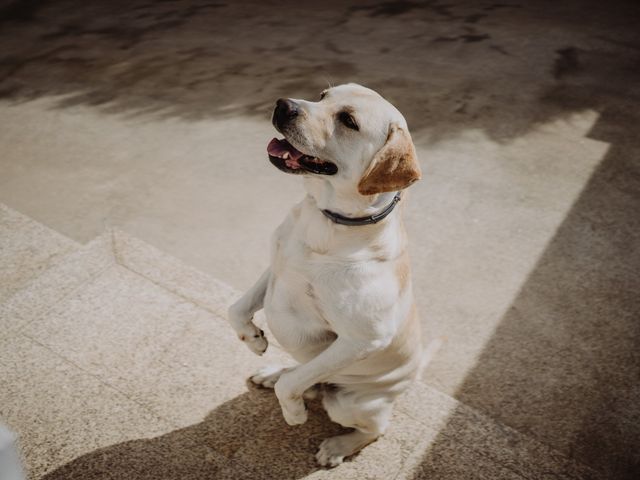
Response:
[397,383,602,480]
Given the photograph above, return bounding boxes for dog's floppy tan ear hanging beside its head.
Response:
[358,124,422,195]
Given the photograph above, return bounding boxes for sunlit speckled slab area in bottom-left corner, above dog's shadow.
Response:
[0,334,201,478]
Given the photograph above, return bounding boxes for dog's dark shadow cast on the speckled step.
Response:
[42,386,346,480]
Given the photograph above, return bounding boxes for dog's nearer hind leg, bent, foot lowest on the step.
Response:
[316,389,393,467]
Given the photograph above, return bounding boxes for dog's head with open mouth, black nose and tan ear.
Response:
[268,83,421,195]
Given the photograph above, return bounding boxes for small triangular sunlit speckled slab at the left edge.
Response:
[0,203,80,304]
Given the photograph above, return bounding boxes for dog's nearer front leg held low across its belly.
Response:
[274,337,388,425]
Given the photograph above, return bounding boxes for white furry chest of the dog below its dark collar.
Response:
[265,198,410,361]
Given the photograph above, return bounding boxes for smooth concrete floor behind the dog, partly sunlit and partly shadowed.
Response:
[0,0,640,478]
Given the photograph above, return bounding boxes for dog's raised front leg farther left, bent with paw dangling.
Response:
[228,268,271,355]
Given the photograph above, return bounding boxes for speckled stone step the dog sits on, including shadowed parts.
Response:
[0,226,598,480]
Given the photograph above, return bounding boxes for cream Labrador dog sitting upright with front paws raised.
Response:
[228,84,422,467]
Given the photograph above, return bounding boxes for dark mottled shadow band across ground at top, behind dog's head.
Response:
[0,0,640,140]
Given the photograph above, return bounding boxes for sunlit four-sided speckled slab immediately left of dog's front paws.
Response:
[22,265,290,426]
